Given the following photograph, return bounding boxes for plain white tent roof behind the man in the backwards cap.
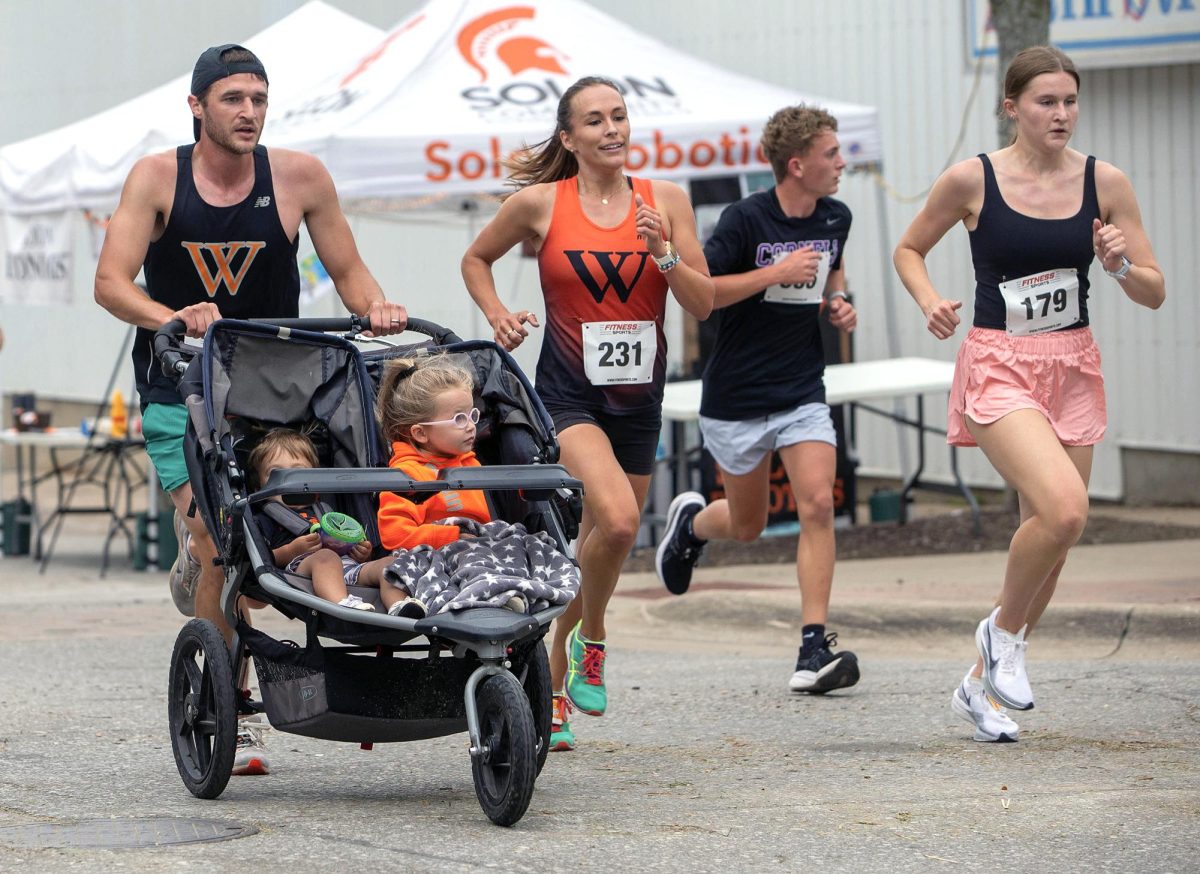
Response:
[0,0,384,215]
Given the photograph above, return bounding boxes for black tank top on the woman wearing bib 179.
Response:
[970,155,1100,330]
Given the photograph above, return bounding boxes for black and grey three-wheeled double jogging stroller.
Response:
[154,318,582,825]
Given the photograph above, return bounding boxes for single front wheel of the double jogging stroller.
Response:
[470,674,538,826]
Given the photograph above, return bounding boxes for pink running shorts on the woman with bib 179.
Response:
[946,328,1108,447]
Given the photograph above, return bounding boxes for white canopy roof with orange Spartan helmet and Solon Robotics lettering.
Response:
[264,0,882,209]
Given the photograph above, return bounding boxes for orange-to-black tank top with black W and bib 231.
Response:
[535,176,667,414]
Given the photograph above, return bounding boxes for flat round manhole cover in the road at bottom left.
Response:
[0,816,258,849]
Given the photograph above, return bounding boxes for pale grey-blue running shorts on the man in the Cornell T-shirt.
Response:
[700,403,838,477]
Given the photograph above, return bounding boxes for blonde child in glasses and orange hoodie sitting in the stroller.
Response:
[377,357,492,566]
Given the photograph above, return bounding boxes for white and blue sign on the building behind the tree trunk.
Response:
[966,0,1200,70]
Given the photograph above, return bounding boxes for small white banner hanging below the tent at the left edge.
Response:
[0,211,74,306]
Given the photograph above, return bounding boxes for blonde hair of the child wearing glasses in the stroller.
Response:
[376,355,475,443]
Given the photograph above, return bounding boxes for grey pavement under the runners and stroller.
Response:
[0,516,1200,872]
